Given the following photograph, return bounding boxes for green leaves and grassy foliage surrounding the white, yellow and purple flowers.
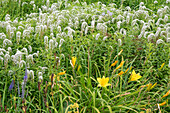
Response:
[0,0,170,113]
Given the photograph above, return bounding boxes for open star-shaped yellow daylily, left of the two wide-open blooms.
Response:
[97,76,111,87]
